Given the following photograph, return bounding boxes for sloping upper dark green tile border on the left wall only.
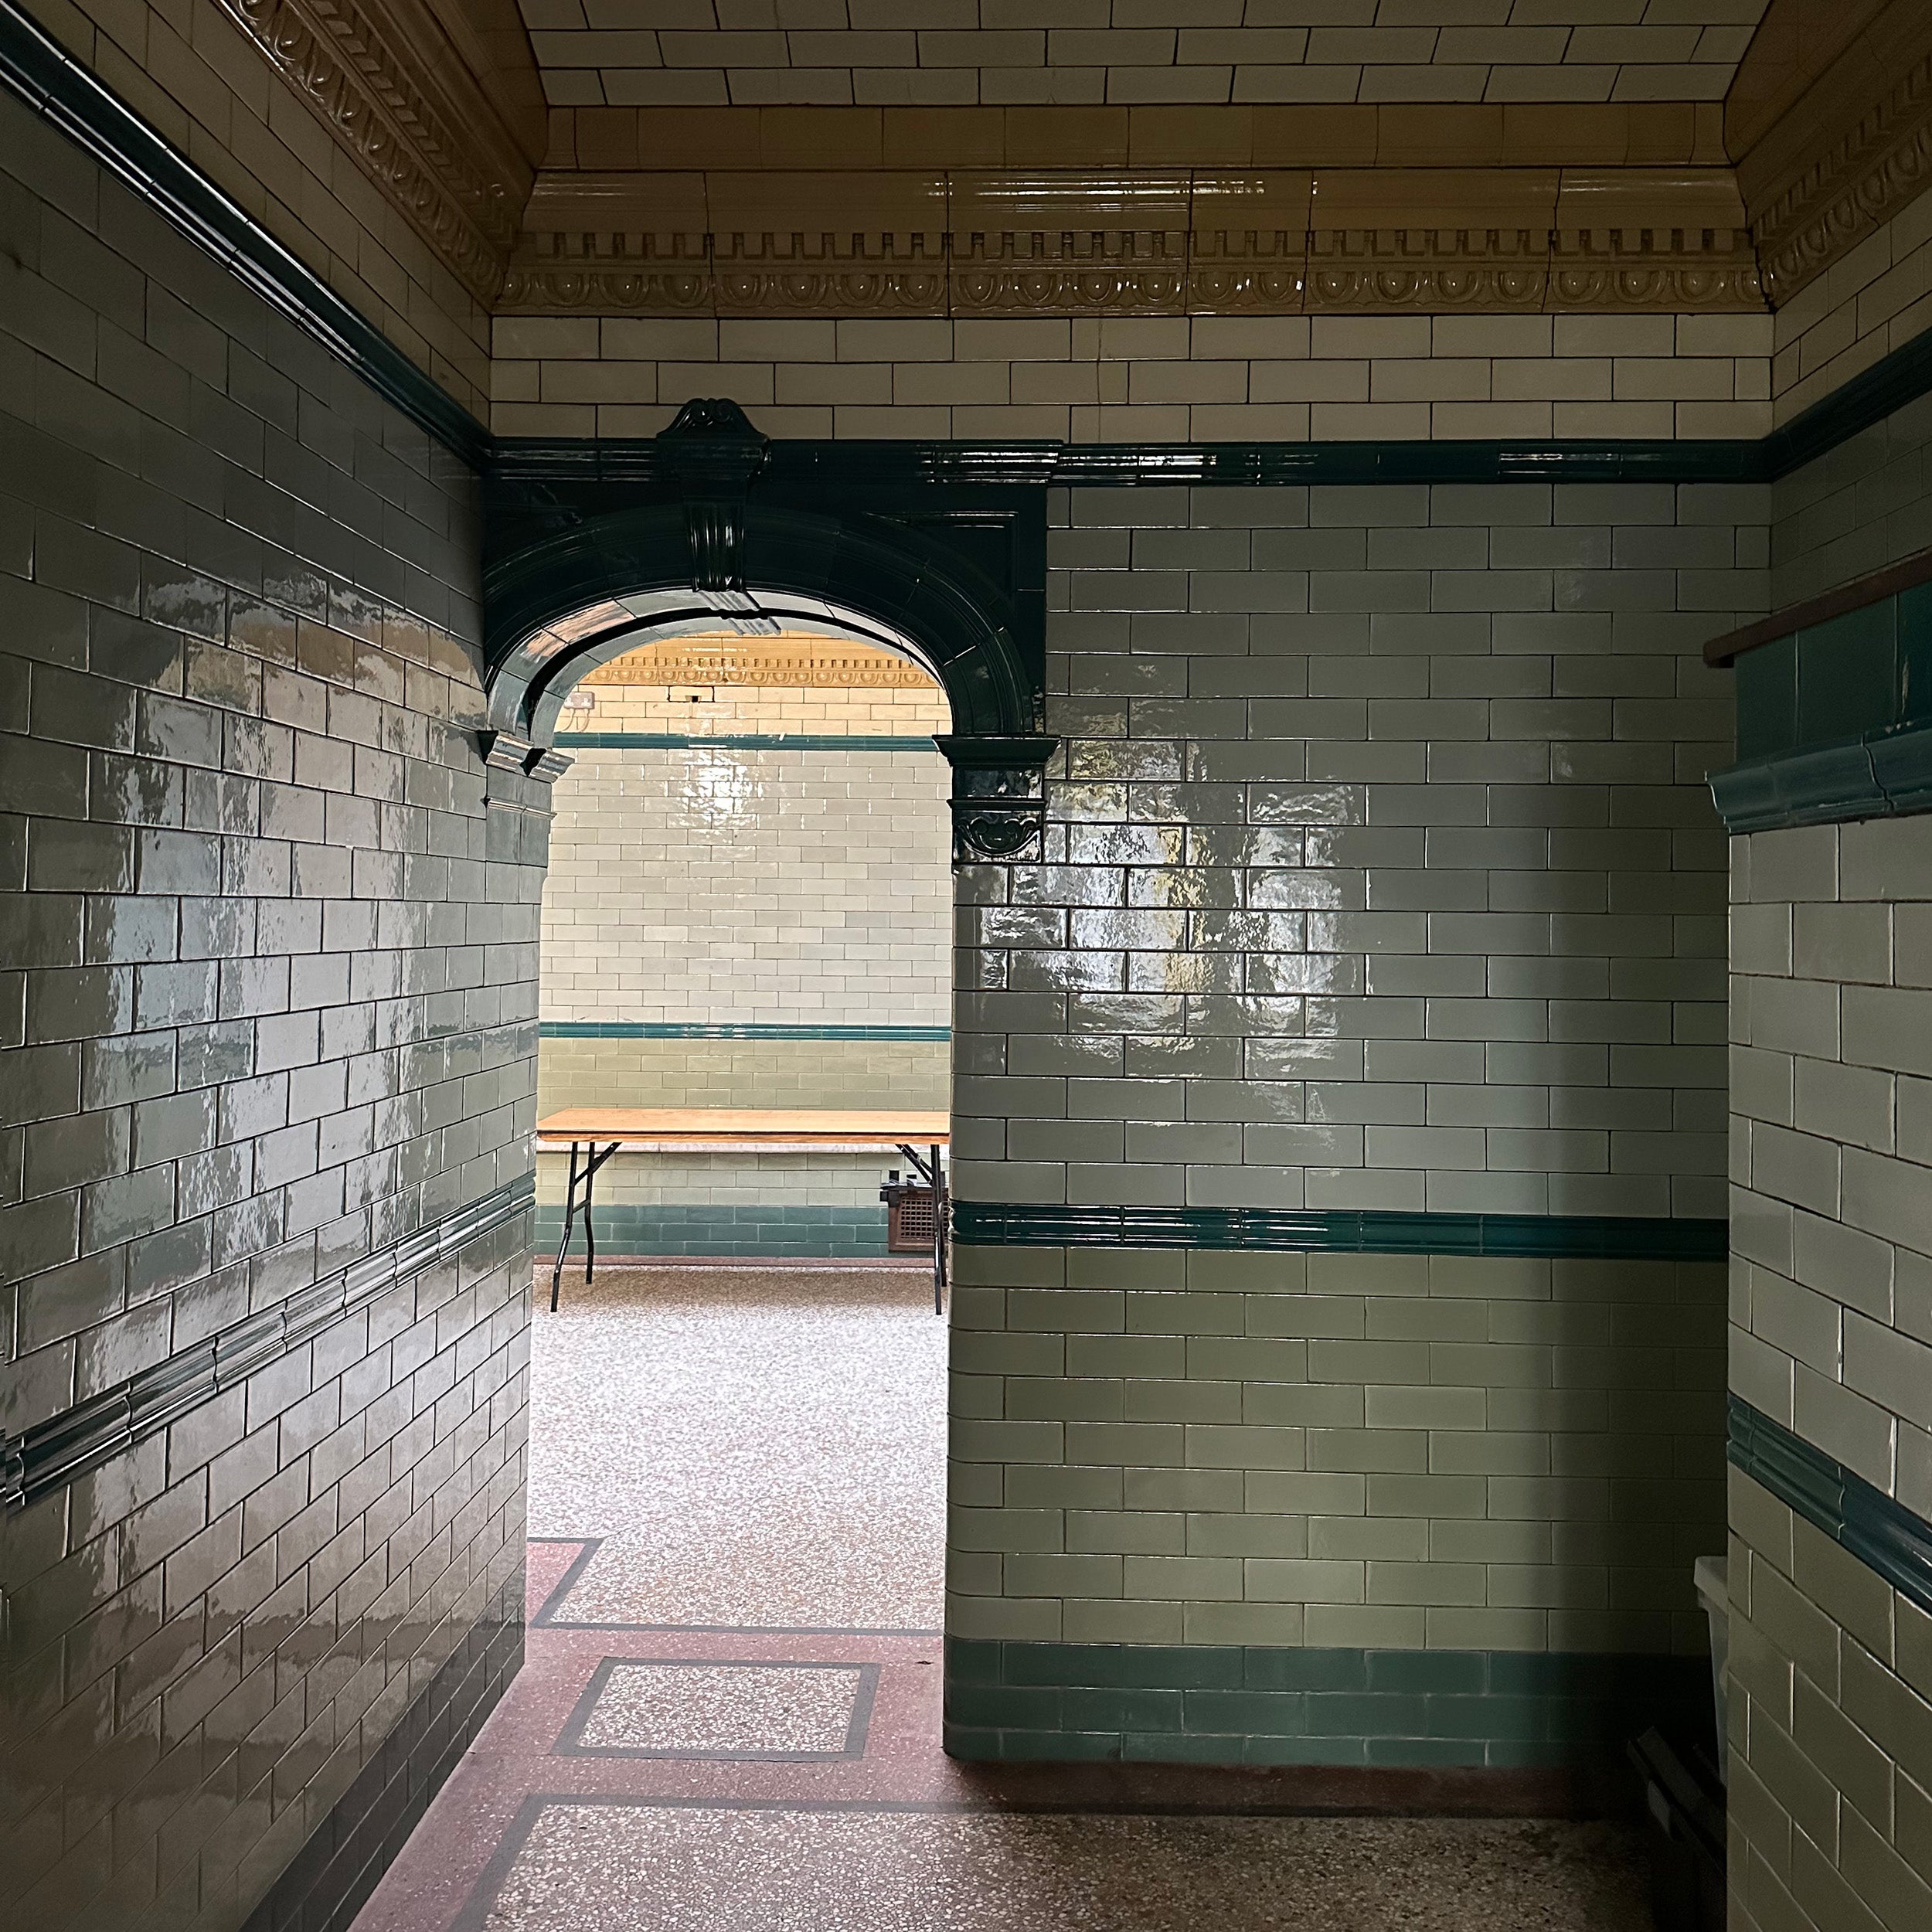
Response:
[0,0,491,464]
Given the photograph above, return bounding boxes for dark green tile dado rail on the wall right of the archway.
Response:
[953,1202,1730,1262]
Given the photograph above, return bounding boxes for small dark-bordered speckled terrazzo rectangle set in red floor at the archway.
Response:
[556,1658,877,1758]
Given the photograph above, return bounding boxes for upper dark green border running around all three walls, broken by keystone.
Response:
[11,0,1932,487]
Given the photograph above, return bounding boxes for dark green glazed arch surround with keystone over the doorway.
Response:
[485,402,1057,860]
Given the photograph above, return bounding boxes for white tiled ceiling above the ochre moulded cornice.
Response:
[522,0,1766,107]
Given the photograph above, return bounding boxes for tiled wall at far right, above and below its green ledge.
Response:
[1730,380,1932,1932]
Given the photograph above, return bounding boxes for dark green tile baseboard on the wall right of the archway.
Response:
[945,1637,1712,1768]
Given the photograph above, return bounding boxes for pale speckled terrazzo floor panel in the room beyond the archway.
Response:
[529,1267,947,1631]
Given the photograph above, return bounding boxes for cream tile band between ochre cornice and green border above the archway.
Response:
[491,315,1772,443]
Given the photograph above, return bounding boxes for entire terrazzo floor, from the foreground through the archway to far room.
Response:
[344,1266,1650,1932]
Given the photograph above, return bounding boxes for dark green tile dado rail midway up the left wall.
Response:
[0,1175,536,1509]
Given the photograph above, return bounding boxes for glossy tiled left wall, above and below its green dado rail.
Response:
[0,87,545,1932]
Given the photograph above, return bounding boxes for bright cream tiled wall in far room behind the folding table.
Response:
[539,684,953,1254]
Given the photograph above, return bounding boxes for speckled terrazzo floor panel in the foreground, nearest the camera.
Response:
[456,1797,1650,1932]
